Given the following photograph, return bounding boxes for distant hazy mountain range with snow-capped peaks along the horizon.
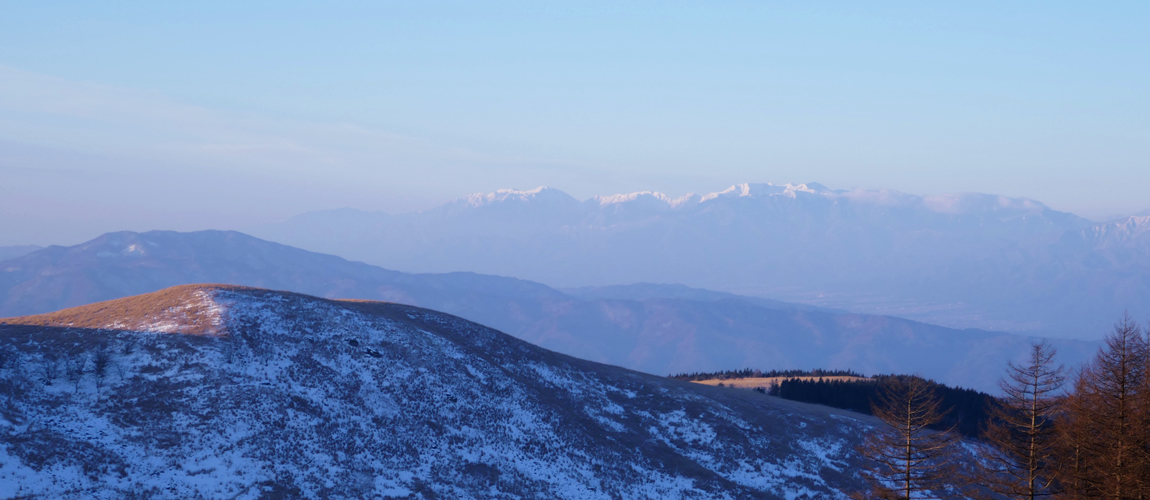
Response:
[251,183,1150,338]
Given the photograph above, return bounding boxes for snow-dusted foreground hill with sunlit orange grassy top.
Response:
[0,286,887,499]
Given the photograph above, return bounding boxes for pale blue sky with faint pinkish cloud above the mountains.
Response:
[0,0,1150,245]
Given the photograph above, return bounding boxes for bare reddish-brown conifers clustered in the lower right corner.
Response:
[854,317,1150,500]
